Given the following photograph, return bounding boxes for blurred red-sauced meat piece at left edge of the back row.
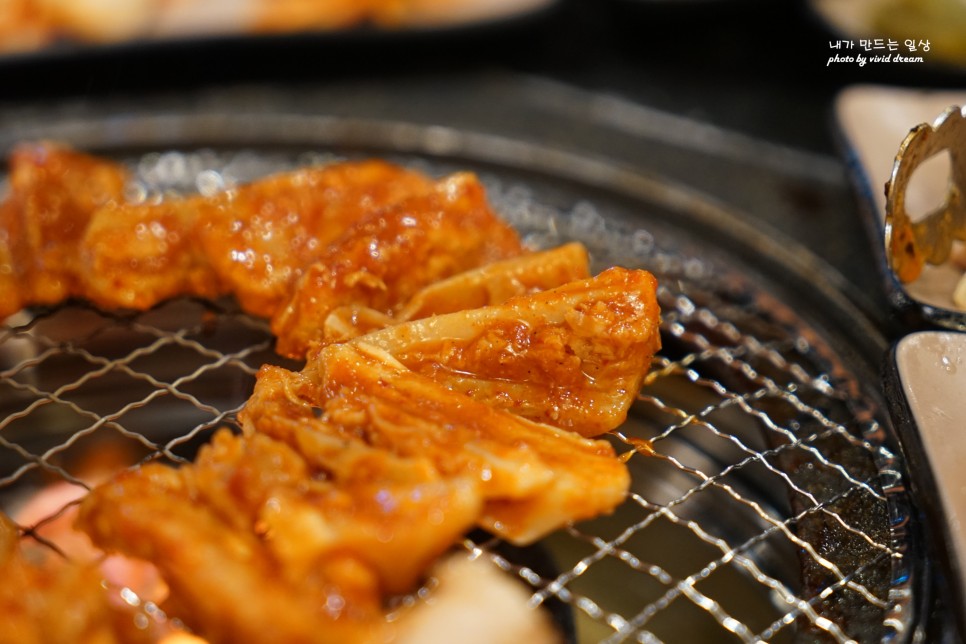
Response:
[0,143,129,319]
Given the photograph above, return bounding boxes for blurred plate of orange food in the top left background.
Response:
[0,0,560,62]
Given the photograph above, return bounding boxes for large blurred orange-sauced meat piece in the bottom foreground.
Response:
[78,430,480,643]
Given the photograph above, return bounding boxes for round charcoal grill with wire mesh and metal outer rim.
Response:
[0,114,927,642]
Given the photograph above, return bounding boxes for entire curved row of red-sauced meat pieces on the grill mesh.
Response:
[0,144,660,643]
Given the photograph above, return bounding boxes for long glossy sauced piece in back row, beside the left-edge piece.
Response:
[83,160,432,317]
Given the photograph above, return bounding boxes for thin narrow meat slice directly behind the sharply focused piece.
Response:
[322,242,590,344]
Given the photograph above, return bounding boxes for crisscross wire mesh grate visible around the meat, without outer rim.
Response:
[0,152,900,642]
